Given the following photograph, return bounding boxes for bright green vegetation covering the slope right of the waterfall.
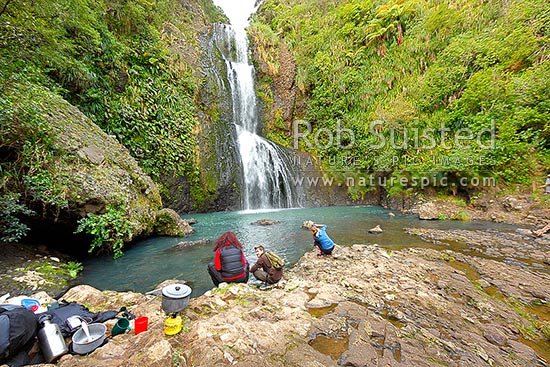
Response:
[251,0,550,197]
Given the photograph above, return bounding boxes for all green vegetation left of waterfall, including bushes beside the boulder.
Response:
[0,0,224,247]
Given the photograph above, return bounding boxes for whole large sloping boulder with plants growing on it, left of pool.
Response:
[0,83,162,247]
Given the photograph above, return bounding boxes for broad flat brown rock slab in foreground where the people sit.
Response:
[22,245,550,367]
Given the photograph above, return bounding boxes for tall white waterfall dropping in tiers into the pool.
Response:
[214,0,299,210]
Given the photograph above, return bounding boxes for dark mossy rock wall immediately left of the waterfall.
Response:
[158,5,241,213]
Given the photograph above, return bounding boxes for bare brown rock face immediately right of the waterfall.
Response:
[250,28,382,207]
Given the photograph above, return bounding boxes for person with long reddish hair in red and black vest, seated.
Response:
[208,232,249,287]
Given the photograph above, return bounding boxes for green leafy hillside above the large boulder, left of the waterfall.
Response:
[0,0,202,178]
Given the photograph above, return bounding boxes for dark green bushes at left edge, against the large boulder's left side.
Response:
[0,82,68,242]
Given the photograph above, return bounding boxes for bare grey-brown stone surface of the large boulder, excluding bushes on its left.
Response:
[49,98,162,237]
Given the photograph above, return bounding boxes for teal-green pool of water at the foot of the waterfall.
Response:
[79,206,515,297]
